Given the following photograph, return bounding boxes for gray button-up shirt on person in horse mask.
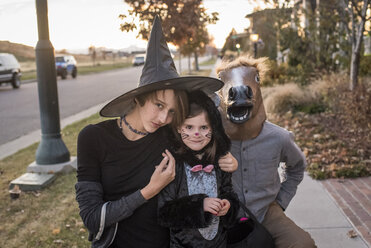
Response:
[231,121,306,222]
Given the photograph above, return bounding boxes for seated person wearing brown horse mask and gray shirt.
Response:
[216,56,316,248]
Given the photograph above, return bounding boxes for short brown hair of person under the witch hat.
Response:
[136,89,188,126]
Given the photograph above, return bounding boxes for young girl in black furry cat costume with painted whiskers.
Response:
[158,91,239,248]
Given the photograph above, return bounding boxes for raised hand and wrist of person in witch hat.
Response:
[140,150,175,200]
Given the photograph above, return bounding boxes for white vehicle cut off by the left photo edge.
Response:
[0,53,22,89]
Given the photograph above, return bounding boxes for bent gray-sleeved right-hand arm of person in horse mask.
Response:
[276,132,307,209]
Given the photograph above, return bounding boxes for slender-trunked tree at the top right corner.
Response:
[339,0,371,91]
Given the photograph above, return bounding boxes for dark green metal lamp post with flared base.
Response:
[35,0,70,165]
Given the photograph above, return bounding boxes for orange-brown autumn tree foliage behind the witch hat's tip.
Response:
[119,0,218,70]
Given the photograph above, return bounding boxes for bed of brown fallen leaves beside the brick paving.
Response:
[269,94,371,179]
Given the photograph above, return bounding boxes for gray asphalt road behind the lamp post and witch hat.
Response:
[0,57,203,146]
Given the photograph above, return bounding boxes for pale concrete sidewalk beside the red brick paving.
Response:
[286,174,371,248]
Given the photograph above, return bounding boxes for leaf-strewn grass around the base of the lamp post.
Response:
[0,114,107,248]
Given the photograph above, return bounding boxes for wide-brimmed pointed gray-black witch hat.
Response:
[100,16,224,117]
